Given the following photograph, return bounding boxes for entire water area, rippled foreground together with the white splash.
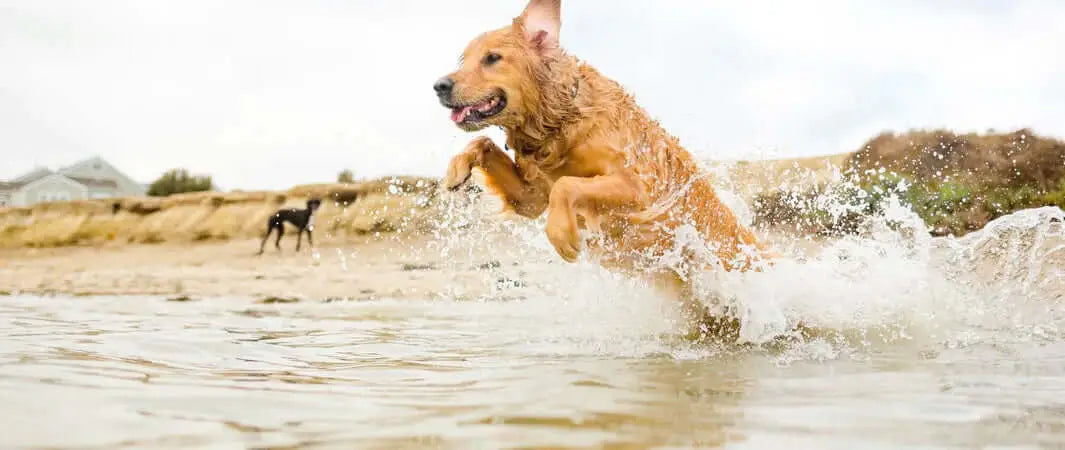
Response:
[0,202,1065,449]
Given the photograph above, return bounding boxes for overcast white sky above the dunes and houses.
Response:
[0,0,1065,189]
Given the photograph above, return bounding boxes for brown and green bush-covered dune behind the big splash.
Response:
[755,130,1065,235]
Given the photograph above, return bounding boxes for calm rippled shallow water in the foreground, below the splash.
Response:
[0,296,1065,449]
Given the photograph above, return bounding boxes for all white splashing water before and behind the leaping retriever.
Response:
[436,164,1065,357]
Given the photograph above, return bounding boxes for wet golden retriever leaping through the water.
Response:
[433,0,765,338]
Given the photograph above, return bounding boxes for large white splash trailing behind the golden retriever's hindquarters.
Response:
[689,171,1065,353]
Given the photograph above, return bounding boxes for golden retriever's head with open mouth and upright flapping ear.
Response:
[432,0,562,131]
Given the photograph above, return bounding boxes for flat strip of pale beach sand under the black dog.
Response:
[0,236,560,301]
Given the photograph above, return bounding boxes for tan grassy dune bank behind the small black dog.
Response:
[0,177,436,247]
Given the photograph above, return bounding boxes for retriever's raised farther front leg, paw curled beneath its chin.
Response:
[443,136,550,218]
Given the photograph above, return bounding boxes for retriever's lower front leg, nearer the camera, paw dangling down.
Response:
[545,174,643,263]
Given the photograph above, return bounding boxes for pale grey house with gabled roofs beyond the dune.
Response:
[0,156,146,206]
